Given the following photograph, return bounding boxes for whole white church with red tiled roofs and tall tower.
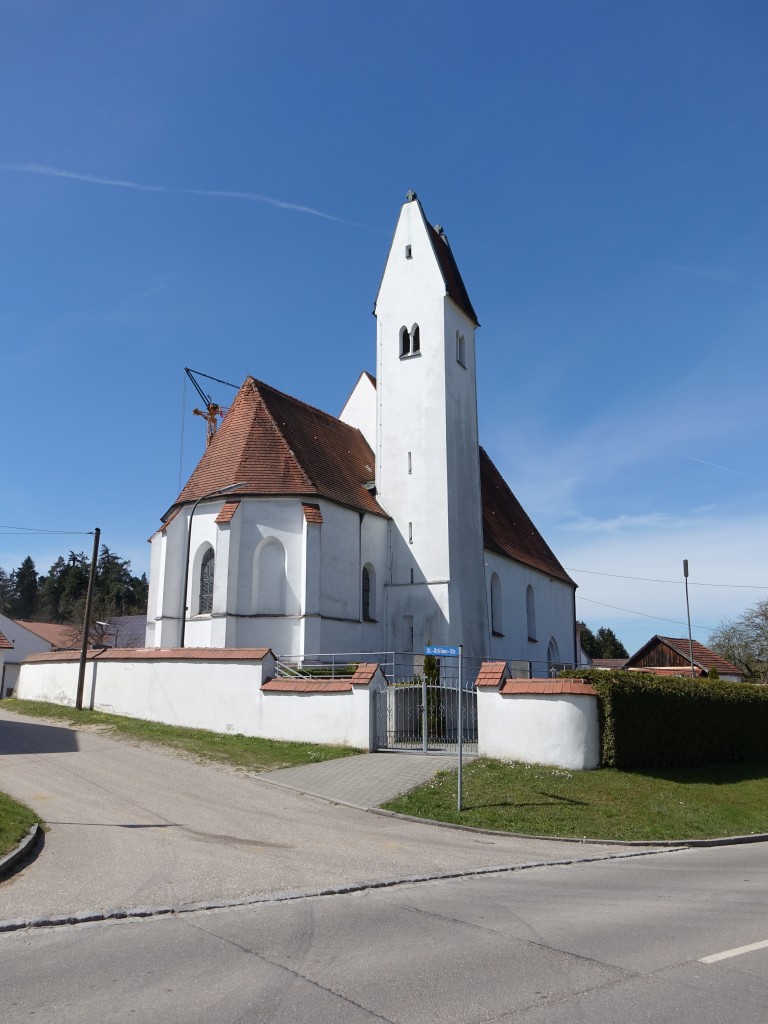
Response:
[146,191,575,676]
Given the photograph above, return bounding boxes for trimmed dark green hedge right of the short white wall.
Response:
[570,669,768,768]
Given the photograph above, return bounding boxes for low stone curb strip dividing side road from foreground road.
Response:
[0,834,677,933]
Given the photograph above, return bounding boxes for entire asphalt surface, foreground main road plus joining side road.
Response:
[0,714,768,1024]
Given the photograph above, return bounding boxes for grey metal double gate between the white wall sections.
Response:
[376,677,477,754]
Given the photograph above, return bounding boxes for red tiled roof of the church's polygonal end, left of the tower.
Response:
[167,377,386,516]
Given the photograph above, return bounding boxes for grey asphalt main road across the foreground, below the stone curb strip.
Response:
[0,845,768,1024]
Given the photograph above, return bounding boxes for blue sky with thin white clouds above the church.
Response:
[0,0,768,650]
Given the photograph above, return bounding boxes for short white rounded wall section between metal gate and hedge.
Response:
[477,687,600,770]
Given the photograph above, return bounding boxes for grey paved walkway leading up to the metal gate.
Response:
[258,753,470,808]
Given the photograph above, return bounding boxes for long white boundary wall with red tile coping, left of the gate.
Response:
[16,648,385,750]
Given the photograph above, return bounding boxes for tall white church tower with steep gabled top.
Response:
[374,191,488,656]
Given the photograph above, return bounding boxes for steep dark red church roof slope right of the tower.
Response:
[480,449,575,586]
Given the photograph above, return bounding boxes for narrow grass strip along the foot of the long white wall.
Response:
[2,697,362,772]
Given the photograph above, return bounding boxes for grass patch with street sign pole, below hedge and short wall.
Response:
[383,758,768,841]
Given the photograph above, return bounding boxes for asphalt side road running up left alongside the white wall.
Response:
[0,710,638,923]
